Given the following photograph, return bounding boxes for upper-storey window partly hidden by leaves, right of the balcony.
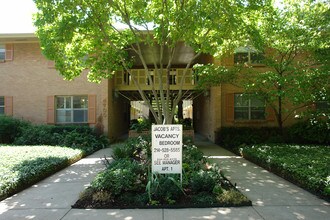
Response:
[234,47,265,64]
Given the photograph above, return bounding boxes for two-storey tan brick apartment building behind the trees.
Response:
[0,34,300,141]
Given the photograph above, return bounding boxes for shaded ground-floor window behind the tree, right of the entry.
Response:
[234,94,265,120]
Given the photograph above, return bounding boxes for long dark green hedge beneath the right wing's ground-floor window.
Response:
[216,118,330,148]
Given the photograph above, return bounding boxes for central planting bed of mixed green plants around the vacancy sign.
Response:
[73,137,251,208]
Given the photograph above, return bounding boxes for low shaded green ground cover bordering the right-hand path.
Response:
[241,144,330,200]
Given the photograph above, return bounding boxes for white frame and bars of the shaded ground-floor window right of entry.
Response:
[234,93,266,121]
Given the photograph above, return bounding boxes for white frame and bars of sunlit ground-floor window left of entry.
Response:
[55,95,88,124]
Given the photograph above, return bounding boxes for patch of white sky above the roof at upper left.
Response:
[0,0,37,34]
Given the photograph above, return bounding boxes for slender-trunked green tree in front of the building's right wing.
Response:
[196,0,330,129]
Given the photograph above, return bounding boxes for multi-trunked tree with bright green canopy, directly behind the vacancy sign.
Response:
[34,0,262,123]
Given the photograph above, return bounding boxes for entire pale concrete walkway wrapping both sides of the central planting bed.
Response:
[0,140,330,220]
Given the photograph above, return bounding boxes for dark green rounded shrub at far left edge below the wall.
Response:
[0,115,29,144]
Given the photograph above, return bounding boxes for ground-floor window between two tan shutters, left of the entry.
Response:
[56,96,88,123]
